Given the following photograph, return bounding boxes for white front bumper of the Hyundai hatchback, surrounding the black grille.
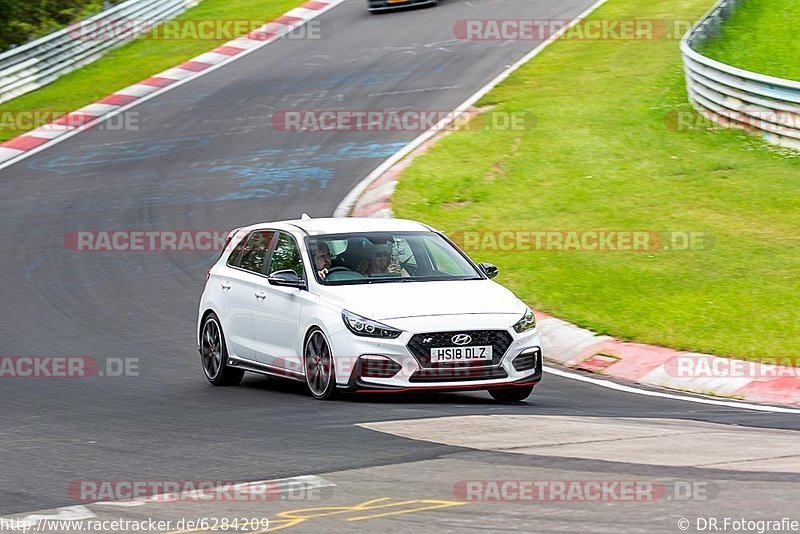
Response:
[330,316,543,392]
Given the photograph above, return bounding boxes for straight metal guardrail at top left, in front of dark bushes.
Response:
[0,0,199,103]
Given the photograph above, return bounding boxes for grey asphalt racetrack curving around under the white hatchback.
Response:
[0,0,800,532]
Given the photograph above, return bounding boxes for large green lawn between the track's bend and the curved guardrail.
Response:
[393,0,800,364]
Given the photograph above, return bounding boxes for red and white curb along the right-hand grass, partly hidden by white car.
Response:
[334,0,800,406]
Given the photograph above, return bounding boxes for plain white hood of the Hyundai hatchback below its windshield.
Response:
[324,280,525,320]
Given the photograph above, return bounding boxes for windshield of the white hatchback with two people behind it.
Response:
[306,232,482,285]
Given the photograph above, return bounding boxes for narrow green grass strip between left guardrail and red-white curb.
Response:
[0,0,305,142]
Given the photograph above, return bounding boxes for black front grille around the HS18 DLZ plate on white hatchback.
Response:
[406,330,513,369]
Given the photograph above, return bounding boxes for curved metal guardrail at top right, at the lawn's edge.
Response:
[681,0,800,149]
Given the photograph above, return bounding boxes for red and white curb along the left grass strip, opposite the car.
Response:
[0,0,344,169]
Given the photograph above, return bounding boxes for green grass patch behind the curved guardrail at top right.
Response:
[701,0,800,80]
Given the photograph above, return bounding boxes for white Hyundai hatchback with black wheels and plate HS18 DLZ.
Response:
[197,216,542,401]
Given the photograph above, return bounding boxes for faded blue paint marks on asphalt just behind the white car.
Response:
[21,138,406,212]
